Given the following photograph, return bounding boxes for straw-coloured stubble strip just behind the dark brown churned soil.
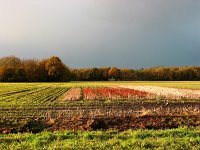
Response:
[0,103,200,120]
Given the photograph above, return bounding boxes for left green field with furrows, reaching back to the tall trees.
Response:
[0,83,70,106]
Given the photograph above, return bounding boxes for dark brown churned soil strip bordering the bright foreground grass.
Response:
[0,116,200,133]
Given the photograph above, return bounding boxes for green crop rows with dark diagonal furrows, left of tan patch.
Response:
[0,86,69,106]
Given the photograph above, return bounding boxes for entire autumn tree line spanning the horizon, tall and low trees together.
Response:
[0,56,200,82]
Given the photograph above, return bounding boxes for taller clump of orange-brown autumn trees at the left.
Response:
[0,56,70,82]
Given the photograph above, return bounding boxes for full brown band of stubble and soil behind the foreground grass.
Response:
[0,102,200,133]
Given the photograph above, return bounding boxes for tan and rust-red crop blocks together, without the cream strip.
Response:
[63,87,151,101]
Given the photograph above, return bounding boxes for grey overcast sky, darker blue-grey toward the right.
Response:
[0,0,200,68]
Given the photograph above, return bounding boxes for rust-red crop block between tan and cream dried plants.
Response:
[83,87,151,100]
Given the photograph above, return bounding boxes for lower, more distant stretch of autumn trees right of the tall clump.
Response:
[71,66,200,81]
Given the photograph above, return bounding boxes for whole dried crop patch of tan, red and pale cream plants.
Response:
[60,86,200,101]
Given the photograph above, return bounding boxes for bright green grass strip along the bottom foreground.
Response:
[0,128,200,150]
